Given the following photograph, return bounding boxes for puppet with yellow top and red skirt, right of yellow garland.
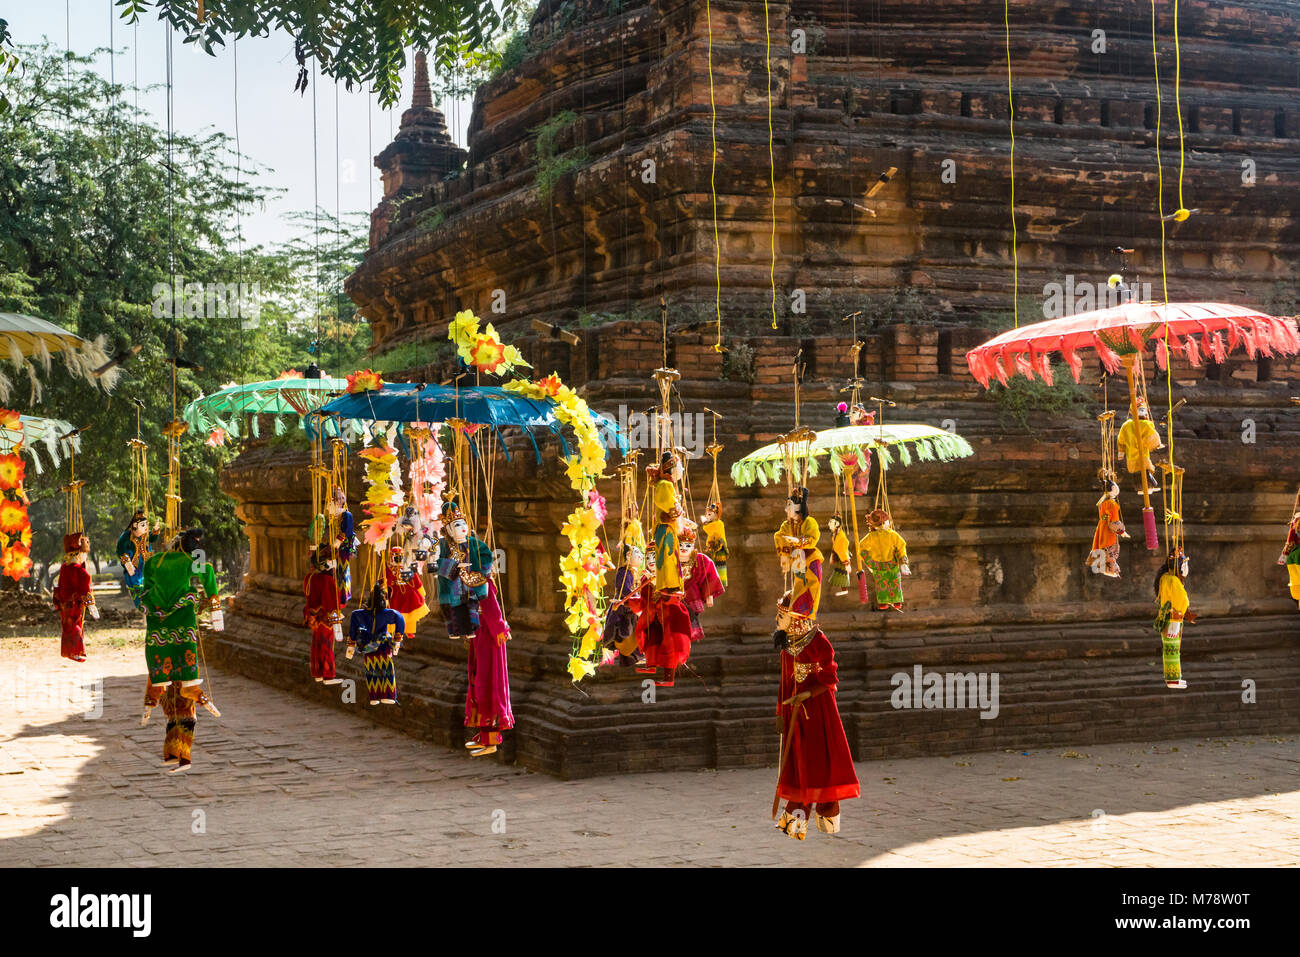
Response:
[628,451,696,688]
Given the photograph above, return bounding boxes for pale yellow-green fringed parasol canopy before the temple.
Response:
[732,423,975,488]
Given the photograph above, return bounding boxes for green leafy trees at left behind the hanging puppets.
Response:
[0,46,369,574]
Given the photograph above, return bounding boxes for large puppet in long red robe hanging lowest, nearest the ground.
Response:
[772,592,861,840]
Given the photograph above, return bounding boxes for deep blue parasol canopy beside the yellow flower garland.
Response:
[312,382,628,459]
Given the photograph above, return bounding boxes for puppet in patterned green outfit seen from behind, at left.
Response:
[140,528,225,743]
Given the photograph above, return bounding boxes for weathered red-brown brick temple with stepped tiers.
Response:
[209,0,1300,776]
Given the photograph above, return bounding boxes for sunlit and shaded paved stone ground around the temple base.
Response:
[0,616,1300,866]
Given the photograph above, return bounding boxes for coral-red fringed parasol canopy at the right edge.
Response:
[966,303,1300,389]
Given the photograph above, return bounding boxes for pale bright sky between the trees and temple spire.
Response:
[4,0,471,244]
